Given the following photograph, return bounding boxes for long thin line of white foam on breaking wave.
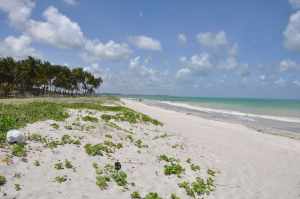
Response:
[160,101,300,123]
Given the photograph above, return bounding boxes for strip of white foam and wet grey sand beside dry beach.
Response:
[130,98,300,140]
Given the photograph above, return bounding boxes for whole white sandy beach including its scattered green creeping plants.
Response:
[0,98,300,199]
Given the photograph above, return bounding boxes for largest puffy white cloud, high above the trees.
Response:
[27,6,85,48]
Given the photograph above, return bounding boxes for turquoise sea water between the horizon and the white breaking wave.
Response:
[128,95,300,118]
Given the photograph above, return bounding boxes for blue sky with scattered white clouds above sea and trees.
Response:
[0,0,300,99]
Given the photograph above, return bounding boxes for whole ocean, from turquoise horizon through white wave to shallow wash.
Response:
[127,95,300,136]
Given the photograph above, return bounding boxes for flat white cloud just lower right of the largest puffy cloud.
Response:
[84,40,132,61]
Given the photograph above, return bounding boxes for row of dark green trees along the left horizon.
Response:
[0,57,103,97]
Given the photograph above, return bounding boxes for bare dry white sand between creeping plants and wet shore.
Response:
[123,99,300,199]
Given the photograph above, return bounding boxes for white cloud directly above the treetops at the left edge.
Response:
[0,35,39,59]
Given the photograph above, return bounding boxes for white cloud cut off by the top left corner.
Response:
[0,0,35,28]
